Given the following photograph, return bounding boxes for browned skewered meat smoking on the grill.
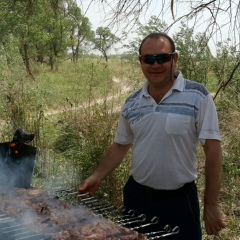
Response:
[0,189,147,240]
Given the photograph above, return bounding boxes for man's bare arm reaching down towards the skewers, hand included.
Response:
[79,142,131,194]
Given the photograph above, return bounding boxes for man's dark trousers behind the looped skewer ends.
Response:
[124,176,202,240]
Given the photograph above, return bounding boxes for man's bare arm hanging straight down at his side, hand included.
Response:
[203,139,225,235]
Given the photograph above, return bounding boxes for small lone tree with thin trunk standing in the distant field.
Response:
[93,27,120,62]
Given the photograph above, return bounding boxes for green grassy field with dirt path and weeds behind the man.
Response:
[0,58,240,240]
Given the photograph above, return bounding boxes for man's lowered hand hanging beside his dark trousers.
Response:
[203,204,226,235]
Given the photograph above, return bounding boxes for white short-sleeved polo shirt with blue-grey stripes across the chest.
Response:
[114,72,220,190]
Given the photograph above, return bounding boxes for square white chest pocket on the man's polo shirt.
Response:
[165,113,191,135]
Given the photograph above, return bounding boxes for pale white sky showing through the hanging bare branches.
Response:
[77,0,240,55]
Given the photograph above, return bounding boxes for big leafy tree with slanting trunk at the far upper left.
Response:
[0,0,66,74]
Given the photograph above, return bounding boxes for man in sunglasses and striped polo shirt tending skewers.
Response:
[80,32,225,240]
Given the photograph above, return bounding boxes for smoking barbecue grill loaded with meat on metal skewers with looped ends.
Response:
[0,188,180,240]
